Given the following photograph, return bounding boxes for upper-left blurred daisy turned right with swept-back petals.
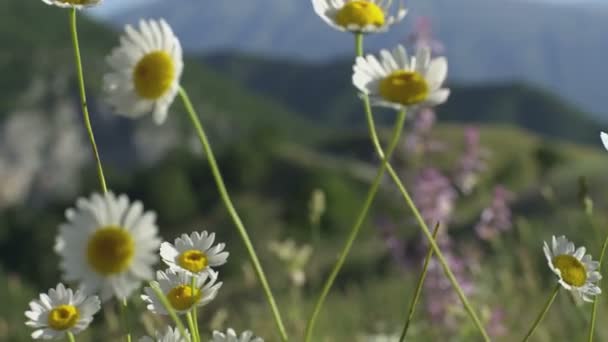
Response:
[103,19,184,124]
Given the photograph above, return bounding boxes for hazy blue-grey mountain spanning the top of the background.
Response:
[106,0,608,118]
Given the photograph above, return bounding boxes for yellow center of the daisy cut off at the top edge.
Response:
[336,0,384,28]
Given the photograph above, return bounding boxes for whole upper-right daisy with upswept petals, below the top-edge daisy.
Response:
[353,45,450,110]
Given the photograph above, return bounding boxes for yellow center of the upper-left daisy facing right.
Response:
[133,51,175,100]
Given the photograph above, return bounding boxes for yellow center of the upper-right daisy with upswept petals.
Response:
[380,70,429,106]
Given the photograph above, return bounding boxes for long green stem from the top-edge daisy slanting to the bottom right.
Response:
[356,33,490,341]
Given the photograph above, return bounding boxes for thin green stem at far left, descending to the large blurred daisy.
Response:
[70,8,108,193]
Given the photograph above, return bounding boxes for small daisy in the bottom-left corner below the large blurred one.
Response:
[25,284,101,340]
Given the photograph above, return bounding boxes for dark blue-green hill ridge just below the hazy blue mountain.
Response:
[203,54,603,144]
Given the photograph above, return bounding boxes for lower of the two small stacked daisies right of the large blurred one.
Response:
[141,269,222,315]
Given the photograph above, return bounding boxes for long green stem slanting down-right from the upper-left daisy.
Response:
[179,87,288,341]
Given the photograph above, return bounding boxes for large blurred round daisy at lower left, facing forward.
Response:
[55,192,160,301]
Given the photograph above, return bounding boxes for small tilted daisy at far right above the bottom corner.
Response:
[543,236,602,302]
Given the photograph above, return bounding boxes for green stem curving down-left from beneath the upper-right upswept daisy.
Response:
[305,111,406,342]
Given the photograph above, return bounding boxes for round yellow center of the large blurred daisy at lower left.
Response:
[87,226,135,275]
